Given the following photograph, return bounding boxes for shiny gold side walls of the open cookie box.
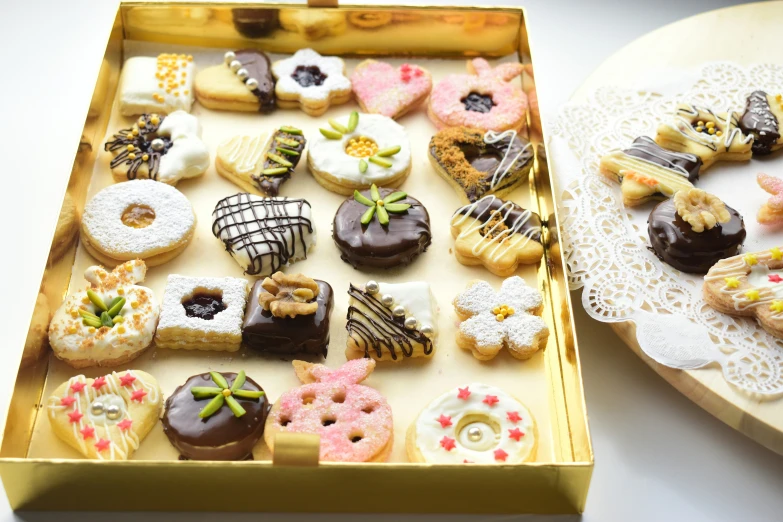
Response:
[0,0,593,513]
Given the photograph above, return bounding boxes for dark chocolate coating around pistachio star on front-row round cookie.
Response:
[161,372,270,460]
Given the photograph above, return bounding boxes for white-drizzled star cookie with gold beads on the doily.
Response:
[655,103,753,172]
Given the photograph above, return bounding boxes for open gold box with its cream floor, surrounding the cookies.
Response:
[0,2,593,513]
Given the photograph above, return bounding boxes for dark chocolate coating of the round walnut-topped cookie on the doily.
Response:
[647,199,746,274]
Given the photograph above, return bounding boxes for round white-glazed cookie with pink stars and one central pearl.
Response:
[406,383,538,464]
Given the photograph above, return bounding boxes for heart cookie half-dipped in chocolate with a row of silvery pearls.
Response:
[195,49,277,113]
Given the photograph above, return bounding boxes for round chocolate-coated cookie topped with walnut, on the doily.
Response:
[647,189,746,274]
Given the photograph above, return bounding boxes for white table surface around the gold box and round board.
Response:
[0,0,783,522]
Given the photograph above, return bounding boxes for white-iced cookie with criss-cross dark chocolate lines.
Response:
[212,193,316,276]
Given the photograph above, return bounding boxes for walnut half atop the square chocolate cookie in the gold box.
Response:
[258,272,318,318]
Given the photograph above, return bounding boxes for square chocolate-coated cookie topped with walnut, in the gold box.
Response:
[242,272,334,357]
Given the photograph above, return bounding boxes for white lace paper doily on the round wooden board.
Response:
[548,62,783,399]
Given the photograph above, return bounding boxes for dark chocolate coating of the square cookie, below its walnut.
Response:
[242,279,334,357]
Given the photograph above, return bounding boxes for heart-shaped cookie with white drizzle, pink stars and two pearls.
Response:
[48,370,163,460]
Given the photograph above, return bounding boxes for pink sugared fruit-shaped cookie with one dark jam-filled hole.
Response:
[427,58,527,134]
